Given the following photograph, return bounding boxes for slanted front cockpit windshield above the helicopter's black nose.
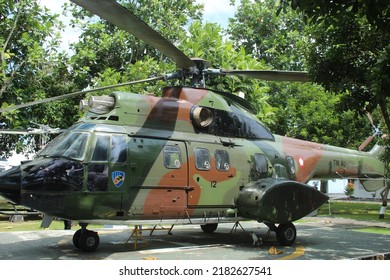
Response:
[39,132,89,160]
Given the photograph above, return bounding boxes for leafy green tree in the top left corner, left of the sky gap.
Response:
[0,0,58,98]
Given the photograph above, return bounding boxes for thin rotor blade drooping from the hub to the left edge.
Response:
[0,76,166,113]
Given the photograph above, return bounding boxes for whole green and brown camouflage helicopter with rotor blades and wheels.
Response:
[0,0,384,251]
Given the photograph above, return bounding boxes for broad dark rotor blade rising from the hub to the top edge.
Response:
[71,0,195,70]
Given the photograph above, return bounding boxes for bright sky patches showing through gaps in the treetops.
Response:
[39,0,235,49]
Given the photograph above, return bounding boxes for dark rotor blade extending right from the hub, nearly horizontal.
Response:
[221,70,309,82]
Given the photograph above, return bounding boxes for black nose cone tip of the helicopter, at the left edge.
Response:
[0,166,21,204]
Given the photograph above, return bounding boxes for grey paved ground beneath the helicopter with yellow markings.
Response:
[0,217,390,260]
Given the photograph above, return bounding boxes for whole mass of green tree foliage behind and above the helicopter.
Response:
[0,0,390,159]
